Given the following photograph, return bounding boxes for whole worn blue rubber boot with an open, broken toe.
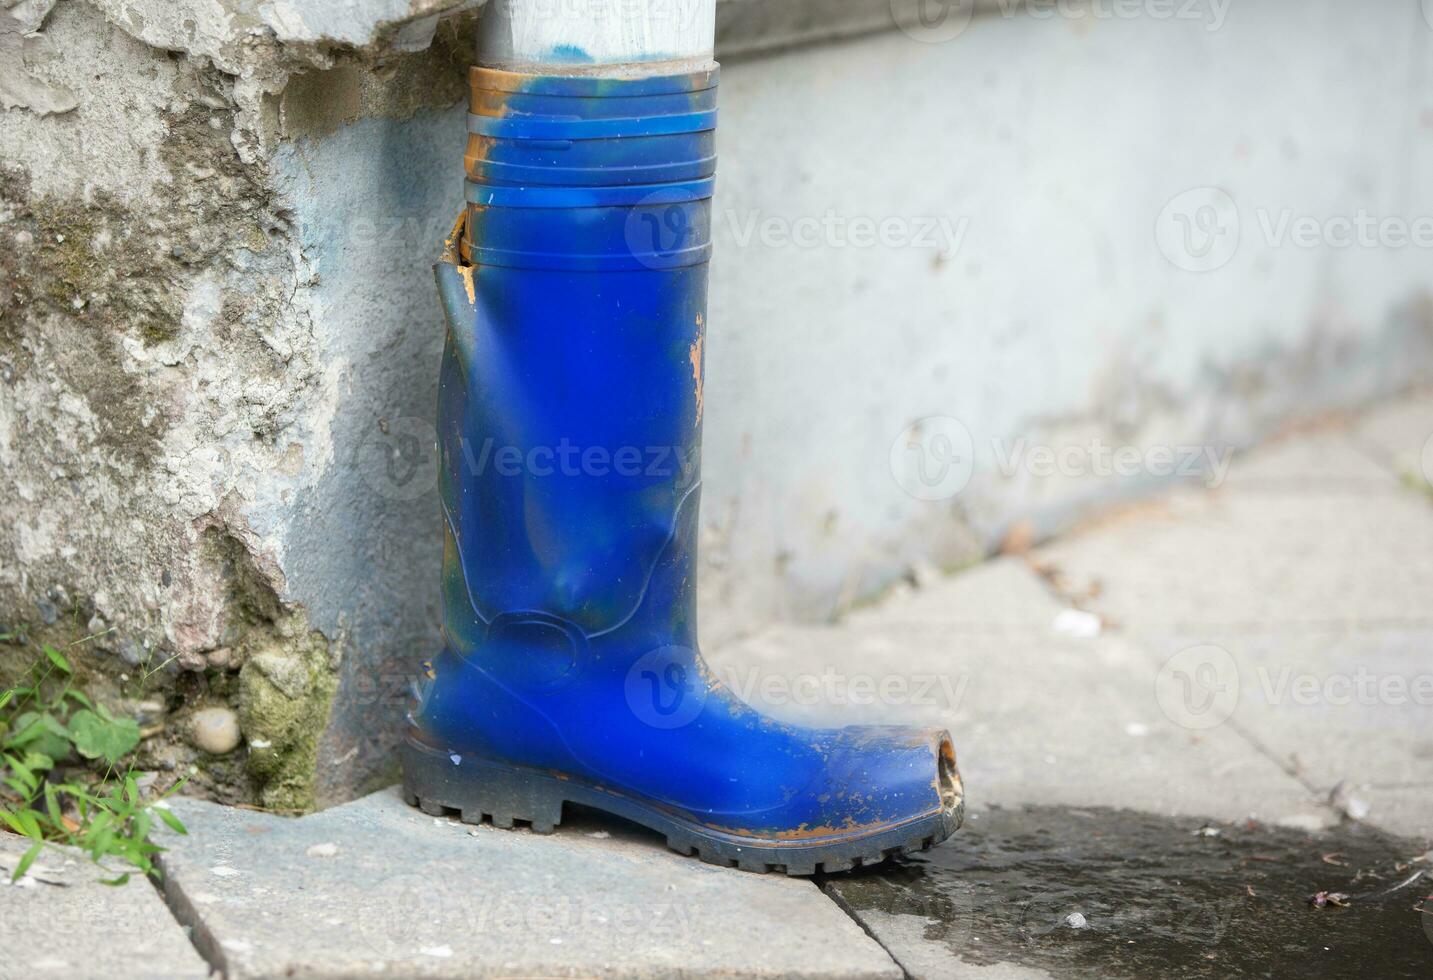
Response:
[403,66,963,874]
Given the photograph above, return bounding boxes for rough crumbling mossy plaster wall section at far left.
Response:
[0,0,471,808]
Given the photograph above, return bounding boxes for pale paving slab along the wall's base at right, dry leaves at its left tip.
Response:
[1036,487,1433,630]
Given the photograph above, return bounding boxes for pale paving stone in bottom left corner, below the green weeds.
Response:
[0,832,209,980]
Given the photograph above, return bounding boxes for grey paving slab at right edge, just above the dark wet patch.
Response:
[1145,629,1433,840]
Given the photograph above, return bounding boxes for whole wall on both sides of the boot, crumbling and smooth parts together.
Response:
[0,0,1433,805]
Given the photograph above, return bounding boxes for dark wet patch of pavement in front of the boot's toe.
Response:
[823,807,1433,980]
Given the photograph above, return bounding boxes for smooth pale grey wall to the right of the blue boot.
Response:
[704,0,1433,622]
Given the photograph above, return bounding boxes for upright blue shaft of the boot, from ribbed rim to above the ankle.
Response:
[437,66,717,649]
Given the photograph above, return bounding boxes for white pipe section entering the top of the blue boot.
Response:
[477,0,717,72]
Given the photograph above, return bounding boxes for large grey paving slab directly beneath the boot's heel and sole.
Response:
[163,789,901,980]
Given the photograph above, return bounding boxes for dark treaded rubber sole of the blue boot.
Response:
[403,738,964,877]
